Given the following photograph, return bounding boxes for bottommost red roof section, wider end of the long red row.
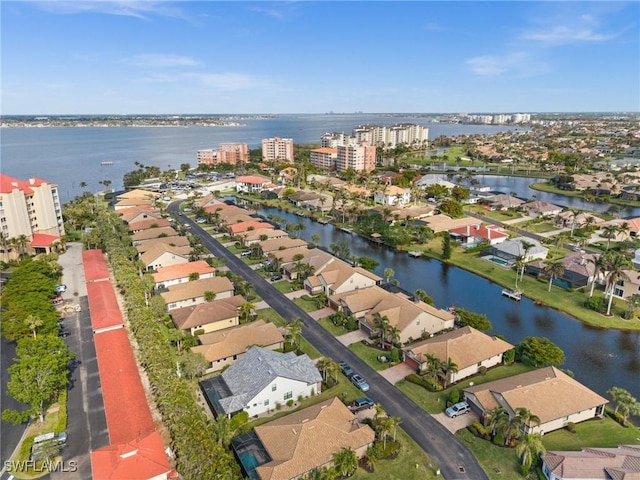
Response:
[91,432,173,480]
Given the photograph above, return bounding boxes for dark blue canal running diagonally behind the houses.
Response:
[257,204,640,399]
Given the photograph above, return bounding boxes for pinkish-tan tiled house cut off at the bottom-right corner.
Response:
[542,445,640,480]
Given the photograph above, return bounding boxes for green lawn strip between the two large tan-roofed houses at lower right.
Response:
[396,362,533,414]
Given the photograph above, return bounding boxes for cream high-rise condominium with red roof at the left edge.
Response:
[0,173,64,260]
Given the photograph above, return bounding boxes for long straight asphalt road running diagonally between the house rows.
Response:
[168,202,488,480]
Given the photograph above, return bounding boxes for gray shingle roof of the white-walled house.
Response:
[219,347,322,413]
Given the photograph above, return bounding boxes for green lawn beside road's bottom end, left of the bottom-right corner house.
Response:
[456,428,522,480]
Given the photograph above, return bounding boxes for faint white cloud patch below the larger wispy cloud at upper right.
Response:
[465,51,548,77]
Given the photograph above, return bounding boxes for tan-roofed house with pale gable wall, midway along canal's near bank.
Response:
[304,259,382,295]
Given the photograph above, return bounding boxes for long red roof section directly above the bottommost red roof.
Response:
[94,328,155,444]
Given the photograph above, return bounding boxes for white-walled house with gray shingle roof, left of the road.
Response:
[200,347,322,417]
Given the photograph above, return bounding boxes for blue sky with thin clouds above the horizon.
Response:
[1,0,640,115]
